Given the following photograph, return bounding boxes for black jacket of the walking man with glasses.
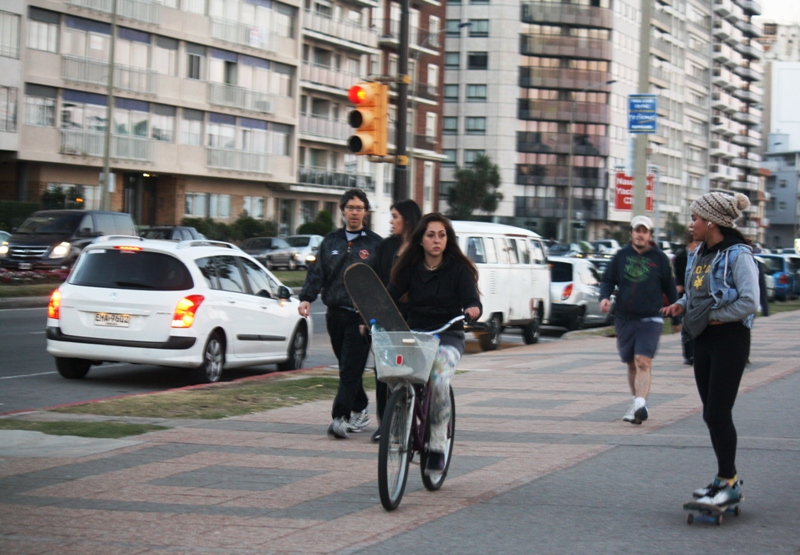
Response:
[300,228,382,308]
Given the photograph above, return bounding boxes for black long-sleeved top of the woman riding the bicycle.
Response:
[389,256,483,331]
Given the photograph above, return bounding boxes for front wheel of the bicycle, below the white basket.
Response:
[378,387,411,511]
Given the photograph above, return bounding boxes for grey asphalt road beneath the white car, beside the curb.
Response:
[0,300,563,414]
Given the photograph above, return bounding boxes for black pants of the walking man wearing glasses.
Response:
[325,308,370,419]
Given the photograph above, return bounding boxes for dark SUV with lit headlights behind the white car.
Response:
[0,210,136,270]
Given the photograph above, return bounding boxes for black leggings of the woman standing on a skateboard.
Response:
[694,322,750,478]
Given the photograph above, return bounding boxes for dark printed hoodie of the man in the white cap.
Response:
[600,243,678,320]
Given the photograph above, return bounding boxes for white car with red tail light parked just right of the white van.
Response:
[548,257,613,330]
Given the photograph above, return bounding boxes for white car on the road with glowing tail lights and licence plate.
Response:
[46,237,312,383]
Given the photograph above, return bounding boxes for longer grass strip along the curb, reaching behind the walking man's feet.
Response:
[52,373,375,420]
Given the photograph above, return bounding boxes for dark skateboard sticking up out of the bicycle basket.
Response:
[344,262,409,331]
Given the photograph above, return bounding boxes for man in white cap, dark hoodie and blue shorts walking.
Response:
[600,216,677,424]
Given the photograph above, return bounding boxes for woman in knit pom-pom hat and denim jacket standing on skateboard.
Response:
[662,192,759,506]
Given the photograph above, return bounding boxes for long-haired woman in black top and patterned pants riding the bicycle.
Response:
[388,214,482,474]
